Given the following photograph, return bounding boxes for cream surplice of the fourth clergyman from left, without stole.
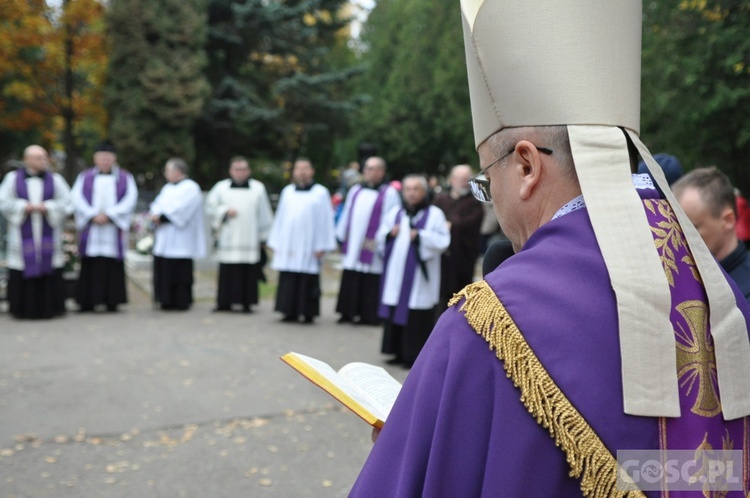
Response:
[206,179,273,264]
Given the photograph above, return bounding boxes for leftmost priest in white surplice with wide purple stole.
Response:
[0,145,72,319]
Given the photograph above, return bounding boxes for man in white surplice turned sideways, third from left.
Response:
[149,158,206,310]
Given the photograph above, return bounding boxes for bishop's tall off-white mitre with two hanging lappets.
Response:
[461,0,750,420]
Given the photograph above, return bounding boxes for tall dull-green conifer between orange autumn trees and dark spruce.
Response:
[105,0,209,182]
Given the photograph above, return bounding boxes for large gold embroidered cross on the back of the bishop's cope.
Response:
[675,301,721,417]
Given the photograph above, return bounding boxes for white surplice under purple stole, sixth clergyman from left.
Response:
[336,185,401,274]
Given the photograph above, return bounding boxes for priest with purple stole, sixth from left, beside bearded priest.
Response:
[336,156,401,325]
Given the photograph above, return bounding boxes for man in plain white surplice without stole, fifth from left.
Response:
[268,157,336,323]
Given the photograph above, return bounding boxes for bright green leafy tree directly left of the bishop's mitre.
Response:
[344,0,476,177]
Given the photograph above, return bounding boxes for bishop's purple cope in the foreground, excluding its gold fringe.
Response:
[351,186,750,498]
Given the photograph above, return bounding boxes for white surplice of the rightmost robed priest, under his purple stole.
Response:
[377,206,451,310]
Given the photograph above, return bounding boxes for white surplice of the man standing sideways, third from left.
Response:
[149,178,206,259]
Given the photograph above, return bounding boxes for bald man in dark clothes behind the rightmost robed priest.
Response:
[435,164,484,312]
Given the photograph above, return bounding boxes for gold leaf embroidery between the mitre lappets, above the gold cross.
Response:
[643,199,701,287]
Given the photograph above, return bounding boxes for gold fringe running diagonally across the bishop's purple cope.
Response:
[448,280,645,498]
